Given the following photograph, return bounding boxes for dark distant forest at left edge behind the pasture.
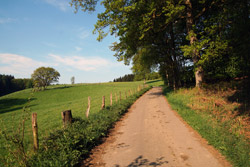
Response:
[0,74,33,96]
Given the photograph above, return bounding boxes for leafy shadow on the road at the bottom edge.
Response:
[114,155,168,167]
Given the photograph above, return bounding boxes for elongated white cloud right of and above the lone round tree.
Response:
[49,54,111,71]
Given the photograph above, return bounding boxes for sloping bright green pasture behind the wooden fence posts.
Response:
[0,80,163,157]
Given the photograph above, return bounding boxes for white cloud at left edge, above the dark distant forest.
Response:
[0,53,46,77]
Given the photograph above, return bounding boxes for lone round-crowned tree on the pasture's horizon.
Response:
[31,67,60,89]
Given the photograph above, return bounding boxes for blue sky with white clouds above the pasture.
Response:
[0,0,131,84]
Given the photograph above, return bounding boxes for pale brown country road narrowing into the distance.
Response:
[83,88,230,167]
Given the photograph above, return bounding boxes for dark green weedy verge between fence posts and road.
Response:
[27,88,150,167]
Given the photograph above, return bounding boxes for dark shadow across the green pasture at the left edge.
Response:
[0,98,36,114]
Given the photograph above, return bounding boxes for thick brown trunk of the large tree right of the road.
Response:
[186,0,203,87]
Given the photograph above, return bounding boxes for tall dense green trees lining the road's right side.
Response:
[71,0,250,88]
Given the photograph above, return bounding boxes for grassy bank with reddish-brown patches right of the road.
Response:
[164,79,250,167]
